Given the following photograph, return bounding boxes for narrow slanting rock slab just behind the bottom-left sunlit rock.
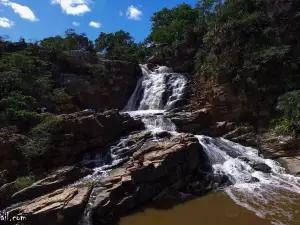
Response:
[6,167,93,207]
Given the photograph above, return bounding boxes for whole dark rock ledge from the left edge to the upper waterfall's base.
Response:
[0,110,144,182]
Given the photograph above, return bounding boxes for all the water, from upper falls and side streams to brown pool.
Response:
[76,65,300,225]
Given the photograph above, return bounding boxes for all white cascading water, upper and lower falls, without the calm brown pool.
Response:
[79,65,300,225]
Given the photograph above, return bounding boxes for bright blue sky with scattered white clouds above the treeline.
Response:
[0,0,197,41]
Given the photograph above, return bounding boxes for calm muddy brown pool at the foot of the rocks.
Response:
[119,192,300,225]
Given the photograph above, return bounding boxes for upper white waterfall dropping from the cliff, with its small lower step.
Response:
[124,65,187,132]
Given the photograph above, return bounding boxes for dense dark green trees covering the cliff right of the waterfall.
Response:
[148,0,300,133]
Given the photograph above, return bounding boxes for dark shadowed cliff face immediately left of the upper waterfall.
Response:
[61,59,142,110]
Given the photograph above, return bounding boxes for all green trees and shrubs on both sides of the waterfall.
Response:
[0,0,300,180]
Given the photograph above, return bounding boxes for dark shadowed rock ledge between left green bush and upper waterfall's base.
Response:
[27,110,144,169]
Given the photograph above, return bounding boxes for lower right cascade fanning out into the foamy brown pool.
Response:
[196,135,300,225]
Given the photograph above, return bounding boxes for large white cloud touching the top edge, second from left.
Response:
[51,0,91,16]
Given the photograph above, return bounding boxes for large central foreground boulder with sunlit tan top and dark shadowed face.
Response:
[91,135,209,224]
